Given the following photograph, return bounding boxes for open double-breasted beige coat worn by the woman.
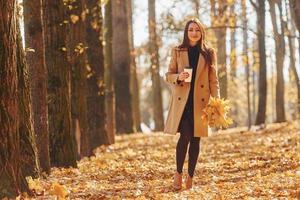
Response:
[164,47,220,137]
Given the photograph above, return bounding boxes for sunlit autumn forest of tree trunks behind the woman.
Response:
[0,0,300,198]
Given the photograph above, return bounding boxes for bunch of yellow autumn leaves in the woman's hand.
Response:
[202,97,233,128]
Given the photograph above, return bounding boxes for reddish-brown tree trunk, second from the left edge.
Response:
[23,0,50,173]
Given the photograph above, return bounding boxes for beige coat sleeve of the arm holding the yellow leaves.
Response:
[209,49,220,98]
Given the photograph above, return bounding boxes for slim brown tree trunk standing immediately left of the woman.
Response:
[148,0,164,131]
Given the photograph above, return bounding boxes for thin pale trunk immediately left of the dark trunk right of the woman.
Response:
[241,0,252,129]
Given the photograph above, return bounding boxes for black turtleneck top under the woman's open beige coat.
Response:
[184,44,200,119]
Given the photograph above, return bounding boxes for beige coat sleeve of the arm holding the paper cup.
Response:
[165,48,181,84]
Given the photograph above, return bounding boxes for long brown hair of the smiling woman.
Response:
[178,18,213,65]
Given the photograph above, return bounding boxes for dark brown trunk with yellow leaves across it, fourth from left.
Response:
[67,0,92,157]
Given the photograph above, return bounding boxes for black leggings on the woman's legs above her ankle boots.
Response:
[176,115,200,177]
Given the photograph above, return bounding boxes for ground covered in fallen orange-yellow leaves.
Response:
[27,121,300,200]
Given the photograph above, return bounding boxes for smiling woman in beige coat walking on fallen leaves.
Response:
[164,19,219,190]
